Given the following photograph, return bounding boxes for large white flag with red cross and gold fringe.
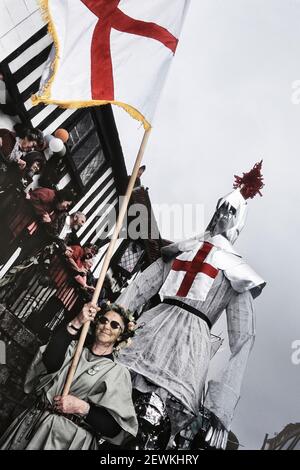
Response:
[33,0,190,129]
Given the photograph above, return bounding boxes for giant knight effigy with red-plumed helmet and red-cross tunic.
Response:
[118,162,265,449]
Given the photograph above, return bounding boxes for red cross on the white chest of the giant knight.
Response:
[172,242,218,297]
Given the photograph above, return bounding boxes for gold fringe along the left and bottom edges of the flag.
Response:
[31,0,151,131]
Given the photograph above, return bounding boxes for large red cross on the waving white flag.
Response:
[79,0,178,101]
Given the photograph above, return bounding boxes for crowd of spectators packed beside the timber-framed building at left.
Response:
[0,114,105,338]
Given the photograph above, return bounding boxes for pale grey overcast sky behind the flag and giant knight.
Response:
[115,0,300,449]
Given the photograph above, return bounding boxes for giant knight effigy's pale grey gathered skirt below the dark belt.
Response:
[118,303,211,415]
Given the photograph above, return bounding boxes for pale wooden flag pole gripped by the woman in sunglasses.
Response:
[62,128,151,396]
